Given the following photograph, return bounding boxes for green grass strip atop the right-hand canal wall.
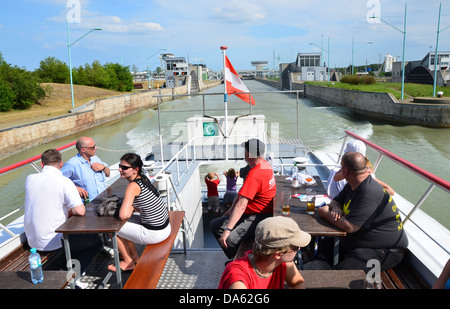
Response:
[305,82,450,99]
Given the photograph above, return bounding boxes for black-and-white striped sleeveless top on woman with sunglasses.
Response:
[133,176,169,230]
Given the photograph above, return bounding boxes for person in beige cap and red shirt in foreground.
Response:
[219,216,311,289]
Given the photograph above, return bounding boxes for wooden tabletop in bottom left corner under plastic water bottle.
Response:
[0,270,75,289]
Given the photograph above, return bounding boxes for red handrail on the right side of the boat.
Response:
[345,131,450,192]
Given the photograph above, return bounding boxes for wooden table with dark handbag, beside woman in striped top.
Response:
[56,178,128,288]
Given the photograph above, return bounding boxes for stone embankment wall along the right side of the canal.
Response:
[258,79,450,128]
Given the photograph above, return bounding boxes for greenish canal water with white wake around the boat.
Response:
[0,81,450,228]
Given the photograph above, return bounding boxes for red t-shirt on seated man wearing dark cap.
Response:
[239,161,277,214]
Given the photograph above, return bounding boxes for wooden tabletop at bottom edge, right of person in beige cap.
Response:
[300,270,366,289]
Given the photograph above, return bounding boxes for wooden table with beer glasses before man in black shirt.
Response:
[273,176,347,266]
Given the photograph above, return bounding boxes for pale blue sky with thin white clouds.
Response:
[0,0,450,71]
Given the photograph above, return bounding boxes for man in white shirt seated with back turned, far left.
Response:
[24,149,103,274]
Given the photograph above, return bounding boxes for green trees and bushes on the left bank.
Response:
[0,53,133,112]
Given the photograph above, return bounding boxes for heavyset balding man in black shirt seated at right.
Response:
[318,152,408,271]
